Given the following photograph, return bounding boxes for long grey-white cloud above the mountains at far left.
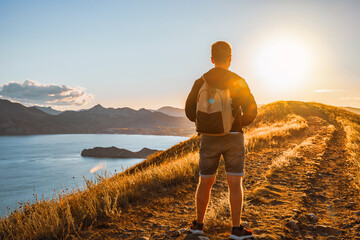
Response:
[0,80,93,106]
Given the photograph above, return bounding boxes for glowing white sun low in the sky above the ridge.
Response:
[253,38,311,92]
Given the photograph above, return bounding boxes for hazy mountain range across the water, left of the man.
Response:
[0,99,194,135]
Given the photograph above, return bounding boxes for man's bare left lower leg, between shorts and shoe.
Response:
[196,176,215,223]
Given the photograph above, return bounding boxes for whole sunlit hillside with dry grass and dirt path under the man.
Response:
[0,101,360,240]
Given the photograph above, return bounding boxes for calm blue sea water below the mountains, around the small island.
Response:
[0,134,188,217]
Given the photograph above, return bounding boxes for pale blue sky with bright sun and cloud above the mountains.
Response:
[0,0,360,110]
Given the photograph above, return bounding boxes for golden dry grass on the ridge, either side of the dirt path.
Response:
[0,101,360,239]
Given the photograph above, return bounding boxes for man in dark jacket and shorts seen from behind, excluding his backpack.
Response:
[185,41,257,239]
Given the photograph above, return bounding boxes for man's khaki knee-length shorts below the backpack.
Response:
[199,133,245,177]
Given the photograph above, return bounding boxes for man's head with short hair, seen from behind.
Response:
[211,41,231,68]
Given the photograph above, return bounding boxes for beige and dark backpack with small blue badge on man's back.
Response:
[195,77,234,136]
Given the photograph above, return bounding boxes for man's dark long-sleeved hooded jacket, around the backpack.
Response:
[185,67,257,132]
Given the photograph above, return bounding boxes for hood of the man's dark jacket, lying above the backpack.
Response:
[202,67,240,89]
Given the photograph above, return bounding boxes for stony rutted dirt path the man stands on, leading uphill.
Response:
[74,117,360,239]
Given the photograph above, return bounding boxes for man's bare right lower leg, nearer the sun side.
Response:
[227,175,244,227]
